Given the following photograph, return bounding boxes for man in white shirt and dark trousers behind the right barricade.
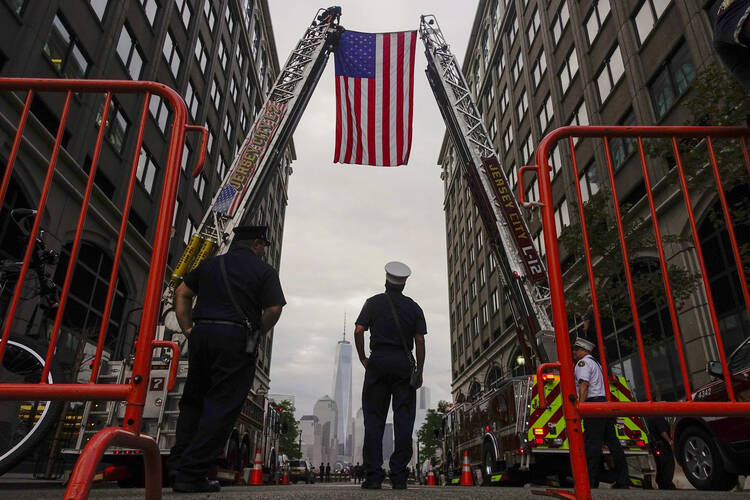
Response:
[573,337,629,488]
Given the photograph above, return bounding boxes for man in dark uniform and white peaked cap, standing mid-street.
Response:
[354,262,427,489]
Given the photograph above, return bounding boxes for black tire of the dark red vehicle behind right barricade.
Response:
[677,426,737,491]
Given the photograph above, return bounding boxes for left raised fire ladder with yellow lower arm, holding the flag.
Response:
[159,7,341,337]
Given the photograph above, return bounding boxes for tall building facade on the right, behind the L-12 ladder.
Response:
[438,0,748,401]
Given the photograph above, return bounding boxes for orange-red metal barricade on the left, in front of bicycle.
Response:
[0,78,208,499]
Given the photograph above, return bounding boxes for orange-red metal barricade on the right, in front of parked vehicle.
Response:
[519,126,750,499]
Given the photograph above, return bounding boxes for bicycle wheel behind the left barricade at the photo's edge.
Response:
[0,337,65,474]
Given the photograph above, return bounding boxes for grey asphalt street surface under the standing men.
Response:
[0,483,748,500]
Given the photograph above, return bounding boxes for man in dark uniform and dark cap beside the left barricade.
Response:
[168,226,286,492]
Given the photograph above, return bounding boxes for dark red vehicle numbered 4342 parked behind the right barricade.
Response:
[674,338,750,490]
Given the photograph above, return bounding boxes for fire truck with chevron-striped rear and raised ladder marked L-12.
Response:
[419,16,655,486]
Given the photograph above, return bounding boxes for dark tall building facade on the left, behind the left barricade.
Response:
[0,0,294,391]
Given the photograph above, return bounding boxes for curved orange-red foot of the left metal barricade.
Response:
[64,427,161,500]
